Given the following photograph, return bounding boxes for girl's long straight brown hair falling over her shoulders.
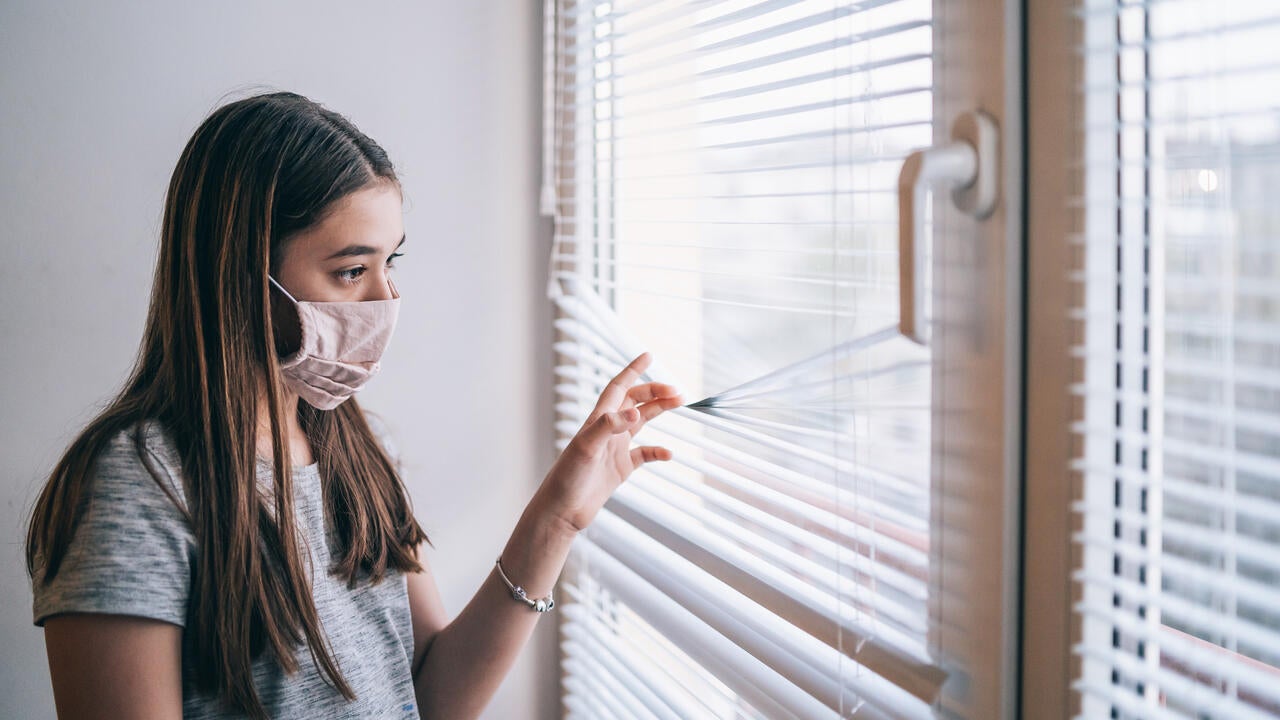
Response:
[27,92,426,717]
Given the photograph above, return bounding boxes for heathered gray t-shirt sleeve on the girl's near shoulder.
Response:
[32,432,195,625]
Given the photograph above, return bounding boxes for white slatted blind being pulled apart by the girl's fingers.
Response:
[541,0,947,719]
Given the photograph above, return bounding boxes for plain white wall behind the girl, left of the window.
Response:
[0,0,557,720]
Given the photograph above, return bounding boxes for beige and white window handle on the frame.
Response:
[897,110,1000,345]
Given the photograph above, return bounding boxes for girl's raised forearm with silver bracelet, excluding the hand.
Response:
[413,498,576,719]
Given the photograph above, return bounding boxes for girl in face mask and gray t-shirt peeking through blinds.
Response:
[27,92,681,719]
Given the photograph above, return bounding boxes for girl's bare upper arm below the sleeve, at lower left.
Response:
[45,614,182,720]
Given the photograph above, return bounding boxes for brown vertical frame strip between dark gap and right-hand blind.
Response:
[1019,0,1080,720]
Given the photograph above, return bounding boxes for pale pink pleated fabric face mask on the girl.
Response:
[268,275,399,410]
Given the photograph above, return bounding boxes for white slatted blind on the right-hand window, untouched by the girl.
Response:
[1073,0,1280,719]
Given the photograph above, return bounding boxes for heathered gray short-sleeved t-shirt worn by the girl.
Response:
[33,423,417,719]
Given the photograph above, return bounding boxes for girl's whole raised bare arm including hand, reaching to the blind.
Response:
[408,355,681,720]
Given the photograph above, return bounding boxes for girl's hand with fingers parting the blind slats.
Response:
[535,352,684,533]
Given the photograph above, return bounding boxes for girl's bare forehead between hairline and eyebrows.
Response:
[292,183,404,255]
